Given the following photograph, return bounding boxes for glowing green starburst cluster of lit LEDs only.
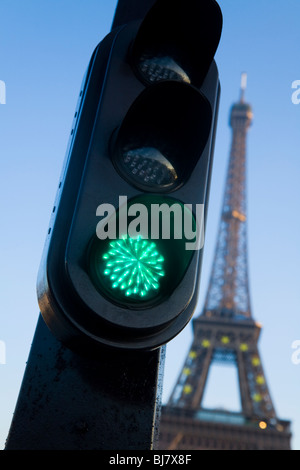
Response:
[102,236,165,298]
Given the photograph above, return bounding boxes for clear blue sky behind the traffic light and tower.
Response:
[0,0,300,449]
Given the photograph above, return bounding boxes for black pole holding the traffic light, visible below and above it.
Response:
[5,0,164,450]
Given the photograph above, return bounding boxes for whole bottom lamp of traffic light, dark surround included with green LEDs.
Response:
[86,194,195,310]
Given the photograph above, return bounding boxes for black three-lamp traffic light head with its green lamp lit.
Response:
[38,0,222,350]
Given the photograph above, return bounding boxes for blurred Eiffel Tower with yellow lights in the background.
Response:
[159,74,291,450]
